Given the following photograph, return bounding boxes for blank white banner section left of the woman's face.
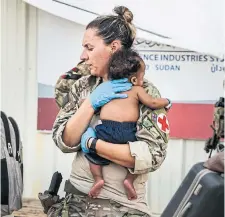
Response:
[37,10,85,85]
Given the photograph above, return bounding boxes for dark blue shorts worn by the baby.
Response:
[85,120,137,165]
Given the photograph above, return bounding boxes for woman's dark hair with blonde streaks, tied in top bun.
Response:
[86,6,136,48]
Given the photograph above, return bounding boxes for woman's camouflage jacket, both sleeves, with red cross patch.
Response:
[53,63,170,174]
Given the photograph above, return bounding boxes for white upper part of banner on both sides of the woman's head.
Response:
[37,8,224,102]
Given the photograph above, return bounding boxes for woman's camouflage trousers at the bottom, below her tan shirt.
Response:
[48,189,149,217]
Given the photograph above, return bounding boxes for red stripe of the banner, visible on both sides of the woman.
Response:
[38,98,214,139]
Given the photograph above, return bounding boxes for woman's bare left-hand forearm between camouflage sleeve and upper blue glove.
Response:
[63,99,94,147]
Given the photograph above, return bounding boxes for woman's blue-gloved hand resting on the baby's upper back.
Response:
[90,78,132,111]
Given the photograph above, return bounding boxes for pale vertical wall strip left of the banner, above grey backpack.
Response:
[1,0,38,196]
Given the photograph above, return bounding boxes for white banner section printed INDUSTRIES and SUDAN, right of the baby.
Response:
[136,43,224,102]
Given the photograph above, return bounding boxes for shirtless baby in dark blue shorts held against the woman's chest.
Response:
[85,49,171,200]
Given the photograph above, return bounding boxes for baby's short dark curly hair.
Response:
[108,49,143,80]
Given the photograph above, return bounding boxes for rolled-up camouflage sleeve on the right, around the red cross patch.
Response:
[129,83,169,174]
